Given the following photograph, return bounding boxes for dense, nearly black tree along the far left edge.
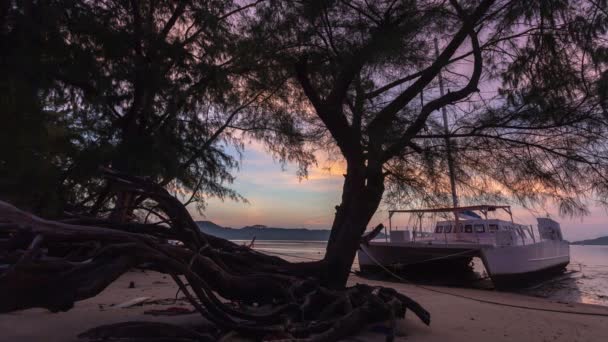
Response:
[0,1,78,215]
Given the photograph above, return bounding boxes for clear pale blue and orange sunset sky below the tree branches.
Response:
[192,143,608,241]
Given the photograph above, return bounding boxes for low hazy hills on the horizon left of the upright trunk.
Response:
[196,221,384,242]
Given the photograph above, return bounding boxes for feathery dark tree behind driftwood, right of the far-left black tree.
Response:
[57,1,251,220]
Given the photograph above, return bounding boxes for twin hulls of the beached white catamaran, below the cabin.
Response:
[358,240,570,288]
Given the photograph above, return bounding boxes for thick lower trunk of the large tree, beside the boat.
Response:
[321,161,384,289]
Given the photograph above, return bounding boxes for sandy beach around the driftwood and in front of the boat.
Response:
[0,271,608,342]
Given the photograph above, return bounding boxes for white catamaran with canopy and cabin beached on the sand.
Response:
[358,205,570,288]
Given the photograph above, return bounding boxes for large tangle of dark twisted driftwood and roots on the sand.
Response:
[0,170,430,341]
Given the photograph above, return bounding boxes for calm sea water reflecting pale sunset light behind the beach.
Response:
[241,241,608,306]
